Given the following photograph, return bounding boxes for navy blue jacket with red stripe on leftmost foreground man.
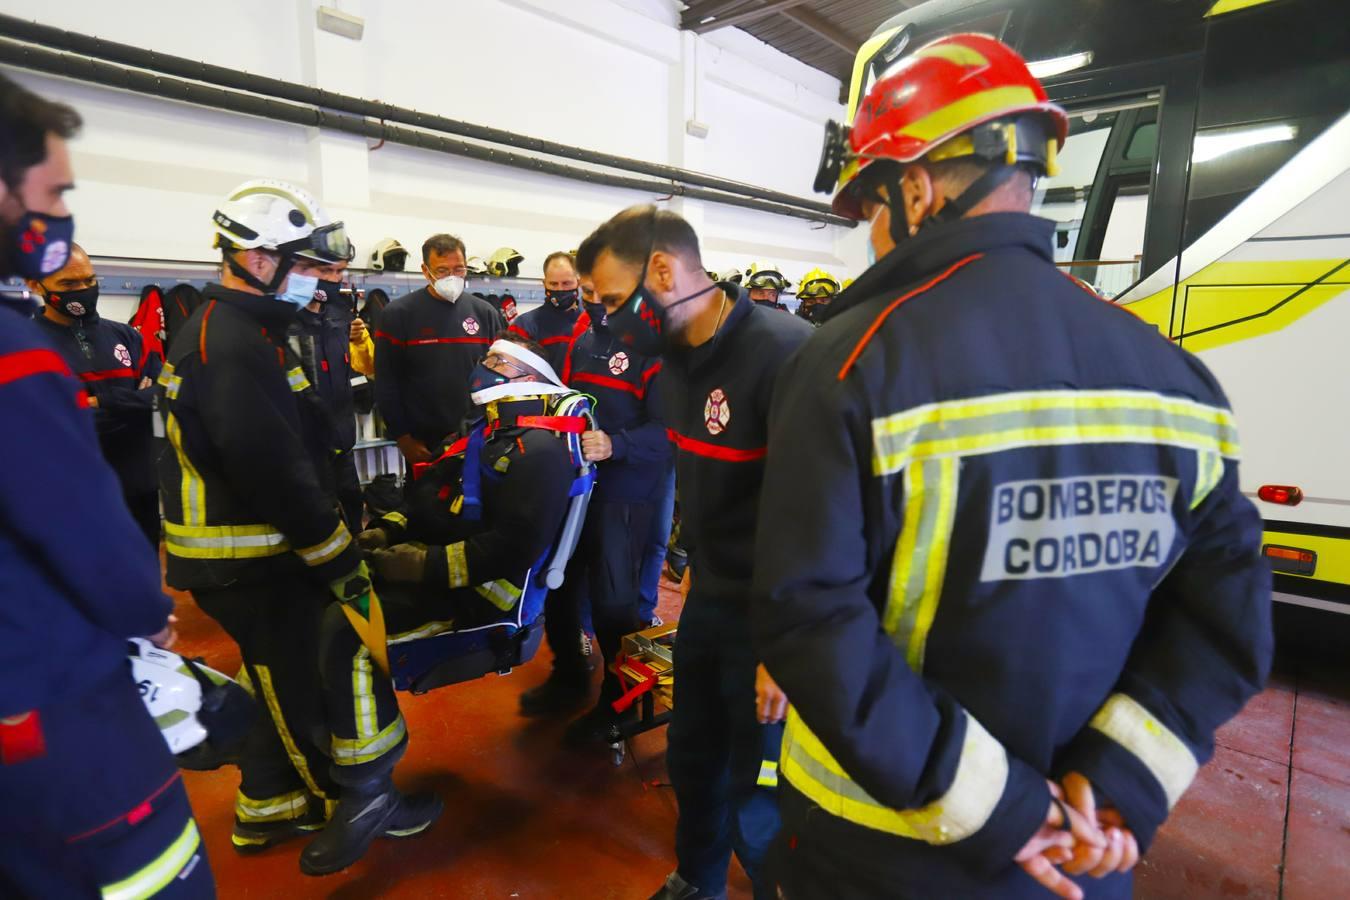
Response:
[0,301,173,718]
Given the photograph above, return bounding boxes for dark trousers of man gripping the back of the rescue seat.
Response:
[544,502,653,702]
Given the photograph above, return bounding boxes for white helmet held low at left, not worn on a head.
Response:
[127,637,255,769]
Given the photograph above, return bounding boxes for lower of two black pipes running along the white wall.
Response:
[0,39,857,227]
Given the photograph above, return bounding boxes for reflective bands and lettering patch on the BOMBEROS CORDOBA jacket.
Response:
[782,391,1238,843]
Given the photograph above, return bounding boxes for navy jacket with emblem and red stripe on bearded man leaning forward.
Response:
[662,285,813,609]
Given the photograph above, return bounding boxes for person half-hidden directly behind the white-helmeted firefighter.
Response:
[290,260,371,534]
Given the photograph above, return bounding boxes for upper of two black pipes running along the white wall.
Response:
[0,15,848,225]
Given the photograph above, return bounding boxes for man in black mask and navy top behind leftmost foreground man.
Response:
[28,244,162,552]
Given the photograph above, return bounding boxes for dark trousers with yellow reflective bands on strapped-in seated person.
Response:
[321,583,514,784]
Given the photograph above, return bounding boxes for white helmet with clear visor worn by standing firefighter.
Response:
[211,178,355,263]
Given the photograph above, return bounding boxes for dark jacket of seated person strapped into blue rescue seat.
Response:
[371,395,585,610]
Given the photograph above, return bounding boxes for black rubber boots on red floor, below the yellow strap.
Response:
[300,773,444,874]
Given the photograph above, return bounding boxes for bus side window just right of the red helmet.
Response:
[1031,97,1158,297]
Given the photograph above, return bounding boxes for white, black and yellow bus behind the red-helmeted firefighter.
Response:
[846,0,1350,615]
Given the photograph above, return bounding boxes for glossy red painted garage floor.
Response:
[176,574,1350,900]
